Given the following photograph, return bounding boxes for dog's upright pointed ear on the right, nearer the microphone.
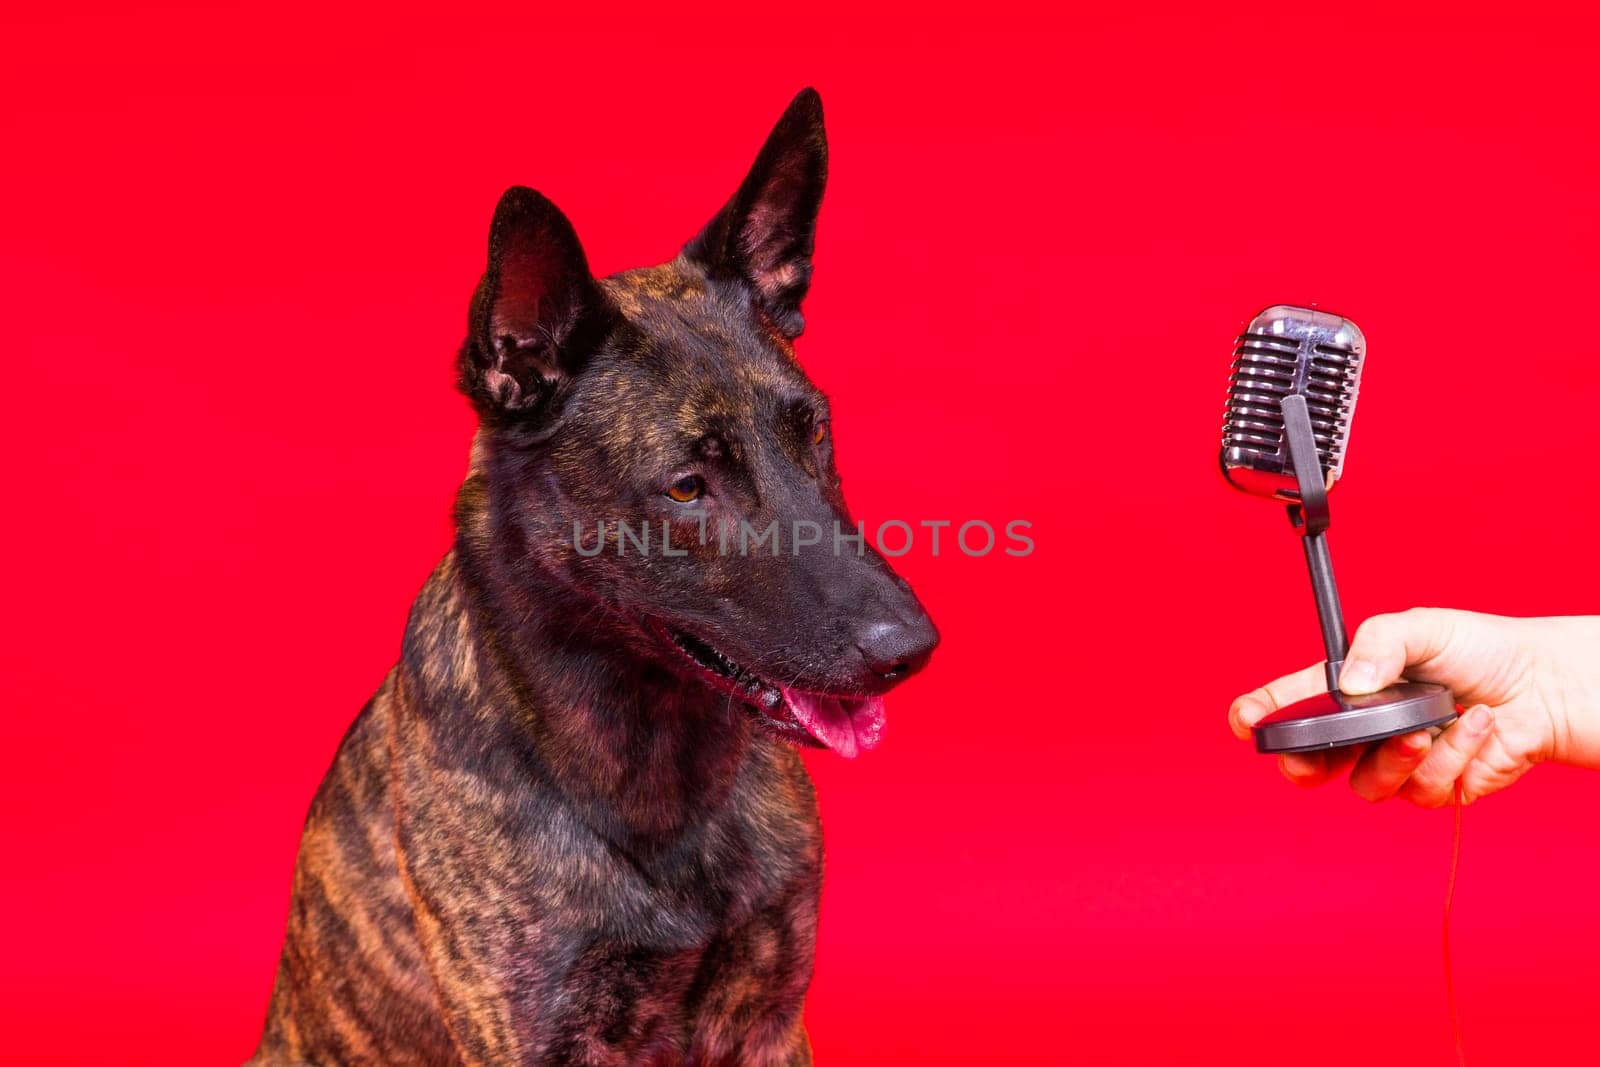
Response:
[683,90,827,338]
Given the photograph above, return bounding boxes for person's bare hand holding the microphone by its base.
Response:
[1227,608,1600,808]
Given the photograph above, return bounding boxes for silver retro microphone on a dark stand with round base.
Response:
[1222,304,1456,752]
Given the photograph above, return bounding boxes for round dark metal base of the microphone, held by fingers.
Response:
[1253,681,1456,752]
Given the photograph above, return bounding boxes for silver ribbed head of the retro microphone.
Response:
[1222,304,1366,501]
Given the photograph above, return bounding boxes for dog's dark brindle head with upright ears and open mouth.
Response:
[461,90,938,757]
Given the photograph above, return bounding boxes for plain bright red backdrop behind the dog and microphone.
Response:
[0,5,1600,1065]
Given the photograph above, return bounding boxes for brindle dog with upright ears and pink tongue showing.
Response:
[251,90,938,1065]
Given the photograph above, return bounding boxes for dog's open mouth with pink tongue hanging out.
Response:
[651,621,883,760]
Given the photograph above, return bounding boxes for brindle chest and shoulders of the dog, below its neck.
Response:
[259,555,821,1064]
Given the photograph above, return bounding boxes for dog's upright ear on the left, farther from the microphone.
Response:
[461,186,608,418]
